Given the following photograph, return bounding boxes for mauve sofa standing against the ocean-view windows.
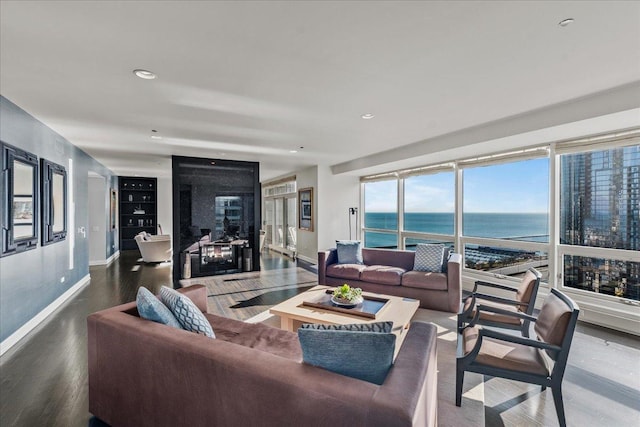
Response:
[318,248,462,313]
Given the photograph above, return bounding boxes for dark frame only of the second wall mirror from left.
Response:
[40,159,67,246]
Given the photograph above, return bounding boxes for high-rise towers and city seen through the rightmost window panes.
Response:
[560,146,640,299]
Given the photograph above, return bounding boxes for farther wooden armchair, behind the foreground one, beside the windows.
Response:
[458,268,542,337]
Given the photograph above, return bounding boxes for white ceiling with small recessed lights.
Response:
[0,0,640,179]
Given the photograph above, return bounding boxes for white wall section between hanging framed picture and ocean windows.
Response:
[315,166,360,252]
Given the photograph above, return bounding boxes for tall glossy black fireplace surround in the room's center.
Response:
[172,156,261,284]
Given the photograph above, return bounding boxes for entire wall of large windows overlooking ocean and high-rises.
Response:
[361,129,640,332]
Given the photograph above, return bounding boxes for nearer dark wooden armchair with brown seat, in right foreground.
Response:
[456,289,579,427]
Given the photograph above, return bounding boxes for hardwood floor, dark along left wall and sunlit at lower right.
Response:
[0,251,640,427]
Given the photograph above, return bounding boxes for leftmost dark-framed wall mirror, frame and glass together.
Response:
[0,143,38,256]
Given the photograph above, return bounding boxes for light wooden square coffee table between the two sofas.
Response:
[269,285,420,358]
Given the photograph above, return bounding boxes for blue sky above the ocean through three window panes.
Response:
[365,158,549,213]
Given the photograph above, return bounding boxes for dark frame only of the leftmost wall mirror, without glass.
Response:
[0,141,40,257]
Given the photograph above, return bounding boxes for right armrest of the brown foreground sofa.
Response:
[367,322,438,426]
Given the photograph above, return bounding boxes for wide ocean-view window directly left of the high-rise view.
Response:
[461,153,549,282]
